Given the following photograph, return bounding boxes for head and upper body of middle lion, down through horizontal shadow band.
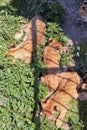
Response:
[43,41,63,74]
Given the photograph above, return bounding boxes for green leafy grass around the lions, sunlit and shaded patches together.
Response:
[0,0,87,130]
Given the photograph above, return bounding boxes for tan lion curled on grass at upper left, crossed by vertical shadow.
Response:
[6,16,46,63]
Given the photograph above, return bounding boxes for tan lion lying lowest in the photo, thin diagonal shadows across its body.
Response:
[41,72,82,128]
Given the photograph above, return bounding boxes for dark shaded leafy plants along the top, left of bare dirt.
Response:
[11,0,65,25]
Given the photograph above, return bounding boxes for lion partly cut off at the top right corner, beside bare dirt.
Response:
[79,1,87,22]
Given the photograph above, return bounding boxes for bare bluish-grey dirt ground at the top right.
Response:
[57,0,87,45]
